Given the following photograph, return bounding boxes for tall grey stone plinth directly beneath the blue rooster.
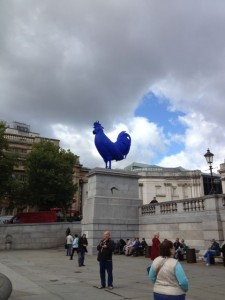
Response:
[82,168,142,255]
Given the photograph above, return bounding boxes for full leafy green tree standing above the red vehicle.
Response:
[25,141,77,211]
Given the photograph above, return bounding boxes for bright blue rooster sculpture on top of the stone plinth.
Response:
[93,121,131,169]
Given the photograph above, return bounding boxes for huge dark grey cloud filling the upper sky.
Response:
[0,0,225,165]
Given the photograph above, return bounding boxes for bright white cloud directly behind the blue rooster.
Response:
[53,117,166,168]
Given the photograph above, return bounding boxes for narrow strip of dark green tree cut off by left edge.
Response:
[0,121,17,199]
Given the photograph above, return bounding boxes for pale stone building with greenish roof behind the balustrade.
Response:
[125,162,222,205]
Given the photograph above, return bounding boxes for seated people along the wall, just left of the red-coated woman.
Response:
[114,237,148,256]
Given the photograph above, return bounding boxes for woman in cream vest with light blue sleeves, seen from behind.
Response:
[149,240,188,300]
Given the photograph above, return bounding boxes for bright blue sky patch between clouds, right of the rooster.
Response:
[135,91,187,159]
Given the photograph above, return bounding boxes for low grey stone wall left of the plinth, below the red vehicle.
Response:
[0,222,81,250]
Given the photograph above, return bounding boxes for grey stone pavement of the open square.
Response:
[0,248,225,300]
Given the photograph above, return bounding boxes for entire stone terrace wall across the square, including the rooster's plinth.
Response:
[0,168,225,255]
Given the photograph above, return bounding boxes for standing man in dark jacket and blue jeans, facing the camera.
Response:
[97,231,115,290]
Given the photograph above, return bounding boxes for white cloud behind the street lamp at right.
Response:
[159,113,225,171]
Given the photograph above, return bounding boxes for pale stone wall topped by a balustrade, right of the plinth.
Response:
[139,195,225,250]
